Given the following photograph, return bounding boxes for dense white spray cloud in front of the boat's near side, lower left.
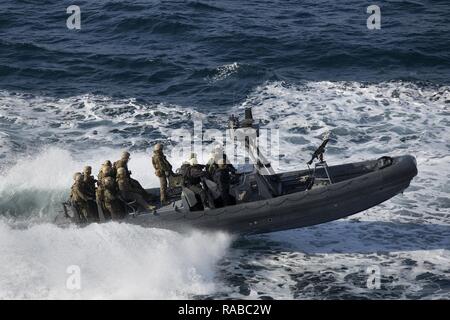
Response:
[0,222,230,299]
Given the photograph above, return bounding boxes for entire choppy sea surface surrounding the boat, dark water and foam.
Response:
[0,0,450,299]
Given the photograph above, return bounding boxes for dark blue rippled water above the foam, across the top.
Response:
[0,0,450,108]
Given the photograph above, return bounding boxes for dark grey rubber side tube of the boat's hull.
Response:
[120,156,417,234]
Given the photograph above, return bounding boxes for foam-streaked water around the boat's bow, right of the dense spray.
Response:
[214,82,450,299]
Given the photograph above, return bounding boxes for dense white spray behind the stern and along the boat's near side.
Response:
[0,148,236,299]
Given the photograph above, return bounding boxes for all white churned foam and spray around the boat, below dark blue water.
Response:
[0,82,450,298]
